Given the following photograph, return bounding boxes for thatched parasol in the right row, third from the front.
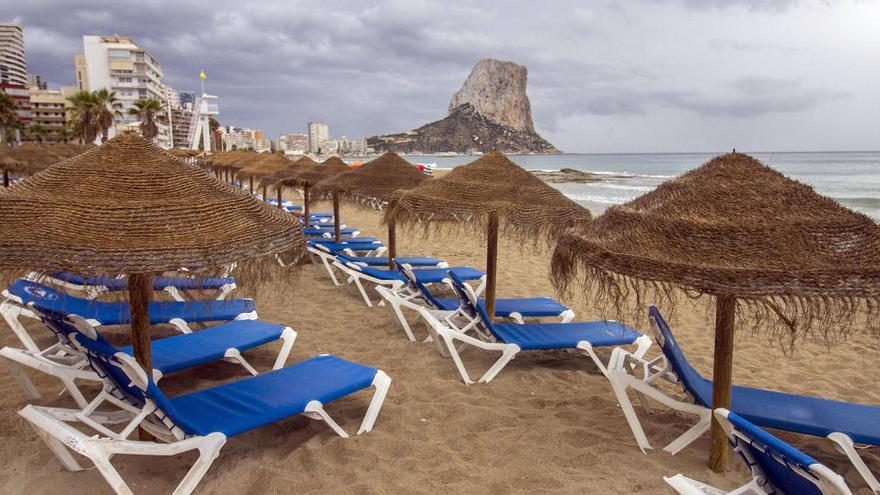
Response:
[312,151,428,260]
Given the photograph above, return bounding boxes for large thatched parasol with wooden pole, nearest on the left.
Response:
[0,134,305,370]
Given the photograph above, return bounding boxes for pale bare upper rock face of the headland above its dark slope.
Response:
[449,58,535,131]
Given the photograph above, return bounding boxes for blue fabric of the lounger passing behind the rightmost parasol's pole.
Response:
[649,306,880,445]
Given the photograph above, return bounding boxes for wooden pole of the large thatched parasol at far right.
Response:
[709,296,736,473]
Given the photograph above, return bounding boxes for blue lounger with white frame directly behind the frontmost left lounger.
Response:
[0,314,296,408]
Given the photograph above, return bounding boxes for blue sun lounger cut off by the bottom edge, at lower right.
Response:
[664,409,852,495]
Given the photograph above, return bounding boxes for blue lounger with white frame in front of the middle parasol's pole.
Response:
[410,272,651,384]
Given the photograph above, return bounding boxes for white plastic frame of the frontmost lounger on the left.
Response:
[18,353,391,495]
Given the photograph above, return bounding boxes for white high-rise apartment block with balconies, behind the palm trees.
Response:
[74,34,170,148]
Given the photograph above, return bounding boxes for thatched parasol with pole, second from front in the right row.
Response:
[385,151,591,317]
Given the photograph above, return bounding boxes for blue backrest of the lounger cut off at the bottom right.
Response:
[715,409,850,495]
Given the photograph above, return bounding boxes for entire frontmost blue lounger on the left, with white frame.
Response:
[19,328,391,494]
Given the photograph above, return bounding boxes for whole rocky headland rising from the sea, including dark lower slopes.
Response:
[367,59,559,153]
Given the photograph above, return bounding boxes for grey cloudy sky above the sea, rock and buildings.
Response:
[0,0,880,152]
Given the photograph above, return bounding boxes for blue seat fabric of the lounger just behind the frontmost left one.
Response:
[119,320,284,375]
